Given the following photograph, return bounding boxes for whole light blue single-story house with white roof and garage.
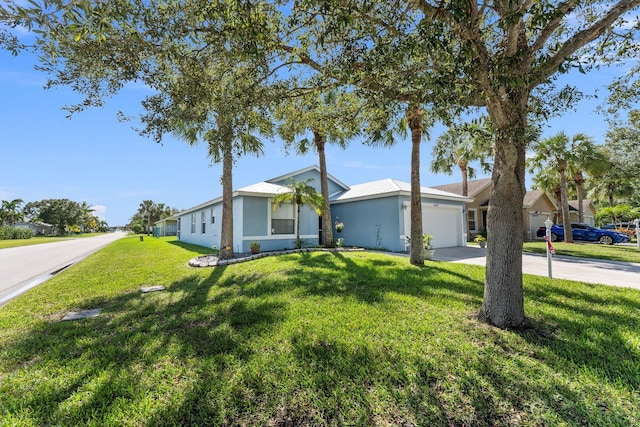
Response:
[175,166,471,252]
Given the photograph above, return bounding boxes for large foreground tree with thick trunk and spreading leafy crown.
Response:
[294,0,640,328]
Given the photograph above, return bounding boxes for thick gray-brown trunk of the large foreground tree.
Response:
[478,97,528,329]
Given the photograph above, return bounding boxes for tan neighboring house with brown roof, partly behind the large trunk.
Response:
[433,178,557,240]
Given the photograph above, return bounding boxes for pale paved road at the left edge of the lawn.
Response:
[0,232,126,305]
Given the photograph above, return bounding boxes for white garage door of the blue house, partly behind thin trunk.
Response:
[404,204,463,248]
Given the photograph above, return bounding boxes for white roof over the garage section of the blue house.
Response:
[331,178,473,203]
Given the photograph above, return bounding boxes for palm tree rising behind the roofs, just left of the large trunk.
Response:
[431,121,491,196]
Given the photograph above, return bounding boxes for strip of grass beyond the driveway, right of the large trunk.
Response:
[523,242,640,263]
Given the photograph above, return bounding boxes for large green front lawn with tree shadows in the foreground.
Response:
[0,238,640,426]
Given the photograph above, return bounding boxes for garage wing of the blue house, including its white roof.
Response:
[331,179,472,252]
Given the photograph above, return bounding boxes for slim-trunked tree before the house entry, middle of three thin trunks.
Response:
[276,91,358,251]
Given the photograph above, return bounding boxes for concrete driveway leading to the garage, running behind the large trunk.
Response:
[433,246,640,289]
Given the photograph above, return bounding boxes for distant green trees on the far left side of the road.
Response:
[0,199,109,235]
